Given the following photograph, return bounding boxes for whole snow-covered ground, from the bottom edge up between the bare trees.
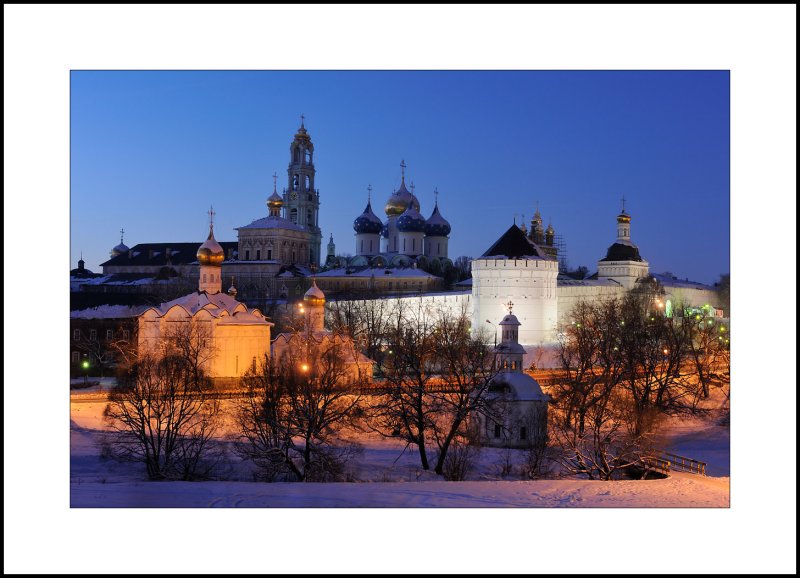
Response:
[70,392,730,507]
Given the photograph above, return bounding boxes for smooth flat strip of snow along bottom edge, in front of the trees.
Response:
[70,474,729,508]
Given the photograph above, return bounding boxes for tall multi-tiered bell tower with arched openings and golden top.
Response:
[283,115,322,265]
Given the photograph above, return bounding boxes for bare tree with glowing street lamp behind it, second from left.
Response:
[237,331,363,481]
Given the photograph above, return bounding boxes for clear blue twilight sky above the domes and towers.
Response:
[70,71,730,283]
